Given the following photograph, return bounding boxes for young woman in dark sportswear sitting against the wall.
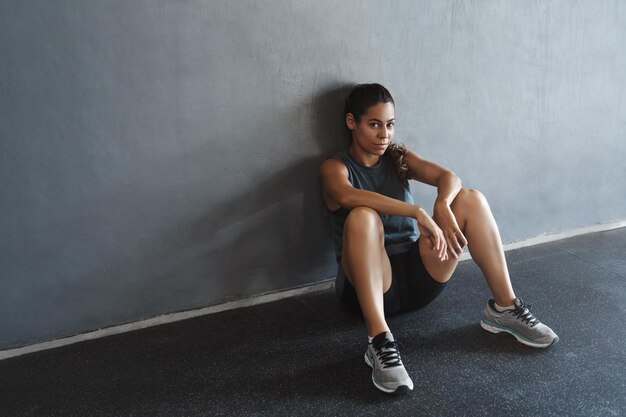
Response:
[320,84,558,393]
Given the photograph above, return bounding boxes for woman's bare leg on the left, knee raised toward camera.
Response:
[341,207,391,336]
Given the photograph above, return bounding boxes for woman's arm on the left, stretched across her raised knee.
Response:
[320,159,447,260]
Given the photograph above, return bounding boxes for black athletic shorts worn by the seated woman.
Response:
[335,240,446,315]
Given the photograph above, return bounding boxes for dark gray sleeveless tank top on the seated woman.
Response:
[329,149,417,259]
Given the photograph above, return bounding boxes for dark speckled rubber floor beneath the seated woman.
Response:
[0,228,626,417]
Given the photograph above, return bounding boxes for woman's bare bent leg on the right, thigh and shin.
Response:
[419,188,515,306]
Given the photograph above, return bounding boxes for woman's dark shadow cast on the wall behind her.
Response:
[108,83,352,312]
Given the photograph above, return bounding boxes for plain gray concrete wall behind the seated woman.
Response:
[0,0,626,349]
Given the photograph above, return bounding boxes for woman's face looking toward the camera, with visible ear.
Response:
[346,103,395,156]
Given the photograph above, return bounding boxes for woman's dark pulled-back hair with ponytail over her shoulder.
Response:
[345,83,409,182]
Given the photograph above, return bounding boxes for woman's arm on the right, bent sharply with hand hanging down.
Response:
[406,151,467,259]
